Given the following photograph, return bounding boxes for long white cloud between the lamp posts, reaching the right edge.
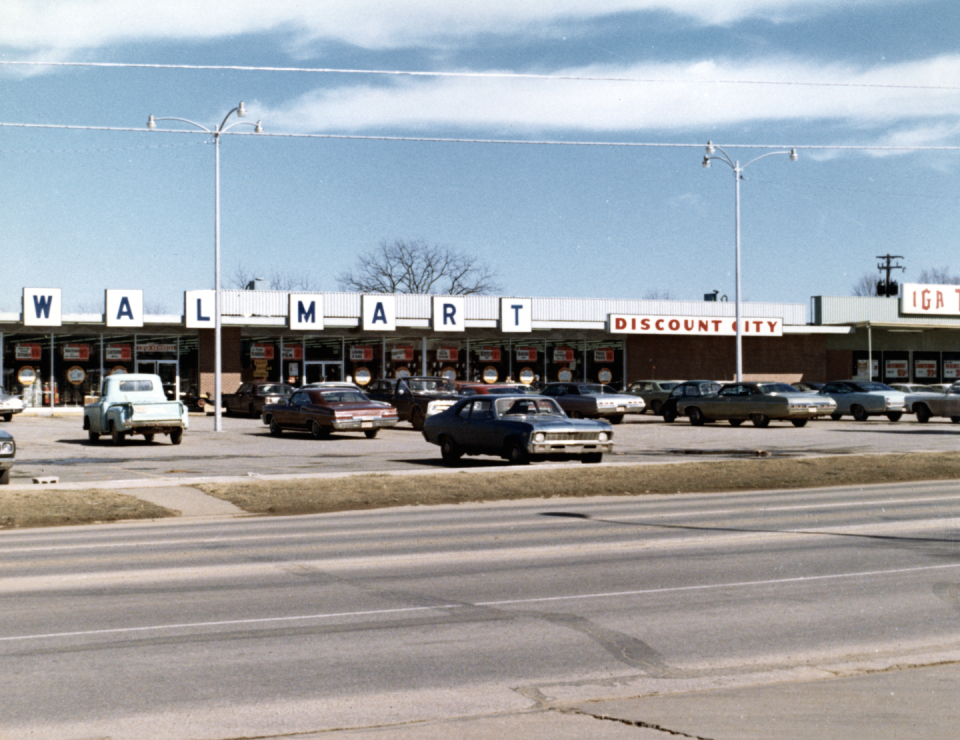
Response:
[256,55,960,140]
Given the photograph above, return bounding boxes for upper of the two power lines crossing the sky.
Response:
[0,60,960,90]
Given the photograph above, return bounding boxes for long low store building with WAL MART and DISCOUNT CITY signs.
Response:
[0,285,960,406]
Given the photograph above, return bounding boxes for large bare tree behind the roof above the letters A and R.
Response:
[337,239,500,295]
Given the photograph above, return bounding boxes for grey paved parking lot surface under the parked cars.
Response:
[2,415,960,484]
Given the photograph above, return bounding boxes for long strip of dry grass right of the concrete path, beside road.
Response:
[196,452,960,515]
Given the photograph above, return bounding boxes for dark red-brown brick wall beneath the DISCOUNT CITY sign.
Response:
[627,334,827,383]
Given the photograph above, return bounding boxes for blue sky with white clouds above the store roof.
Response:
[0,0,960,312]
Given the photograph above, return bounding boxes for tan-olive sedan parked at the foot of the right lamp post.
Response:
[677,383,837,428]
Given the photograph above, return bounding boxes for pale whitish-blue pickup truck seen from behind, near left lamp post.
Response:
[83,374,190,445]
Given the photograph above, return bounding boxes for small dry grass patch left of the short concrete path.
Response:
[0,491,177,529]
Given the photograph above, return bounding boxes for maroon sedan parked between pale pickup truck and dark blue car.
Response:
[262,388,400,439]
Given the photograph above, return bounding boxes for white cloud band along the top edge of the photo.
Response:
[0,0,906,53]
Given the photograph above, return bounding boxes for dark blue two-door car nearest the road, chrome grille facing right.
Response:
[423,395,613,465]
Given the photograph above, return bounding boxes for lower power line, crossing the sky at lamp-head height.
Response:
[0,122,960,152]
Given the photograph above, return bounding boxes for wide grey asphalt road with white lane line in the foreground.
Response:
[0,482,960,740]
